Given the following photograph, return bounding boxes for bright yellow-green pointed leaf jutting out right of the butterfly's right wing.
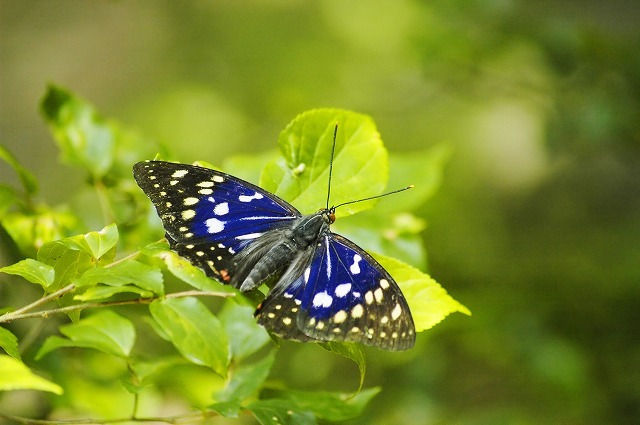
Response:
[374,254,471,332]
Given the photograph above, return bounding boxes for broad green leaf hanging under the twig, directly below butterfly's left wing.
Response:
[149,297,229,376]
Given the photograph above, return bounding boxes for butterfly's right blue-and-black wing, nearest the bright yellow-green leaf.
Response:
[256,233,415,350]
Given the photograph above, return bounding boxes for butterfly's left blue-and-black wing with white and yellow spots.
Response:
[133,161,301,282]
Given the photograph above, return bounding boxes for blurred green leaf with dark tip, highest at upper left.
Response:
[41,85,115,177]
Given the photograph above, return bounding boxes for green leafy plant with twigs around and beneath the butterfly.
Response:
[0,86,469,424]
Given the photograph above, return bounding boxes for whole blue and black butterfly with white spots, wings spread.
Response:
[133,140,415,350]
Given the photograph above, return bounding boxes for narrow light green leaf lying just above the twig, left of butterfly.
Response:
[76,260,164,299]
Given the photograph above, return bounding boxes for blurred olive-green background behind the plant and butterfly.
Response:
[0,0,640,424]
